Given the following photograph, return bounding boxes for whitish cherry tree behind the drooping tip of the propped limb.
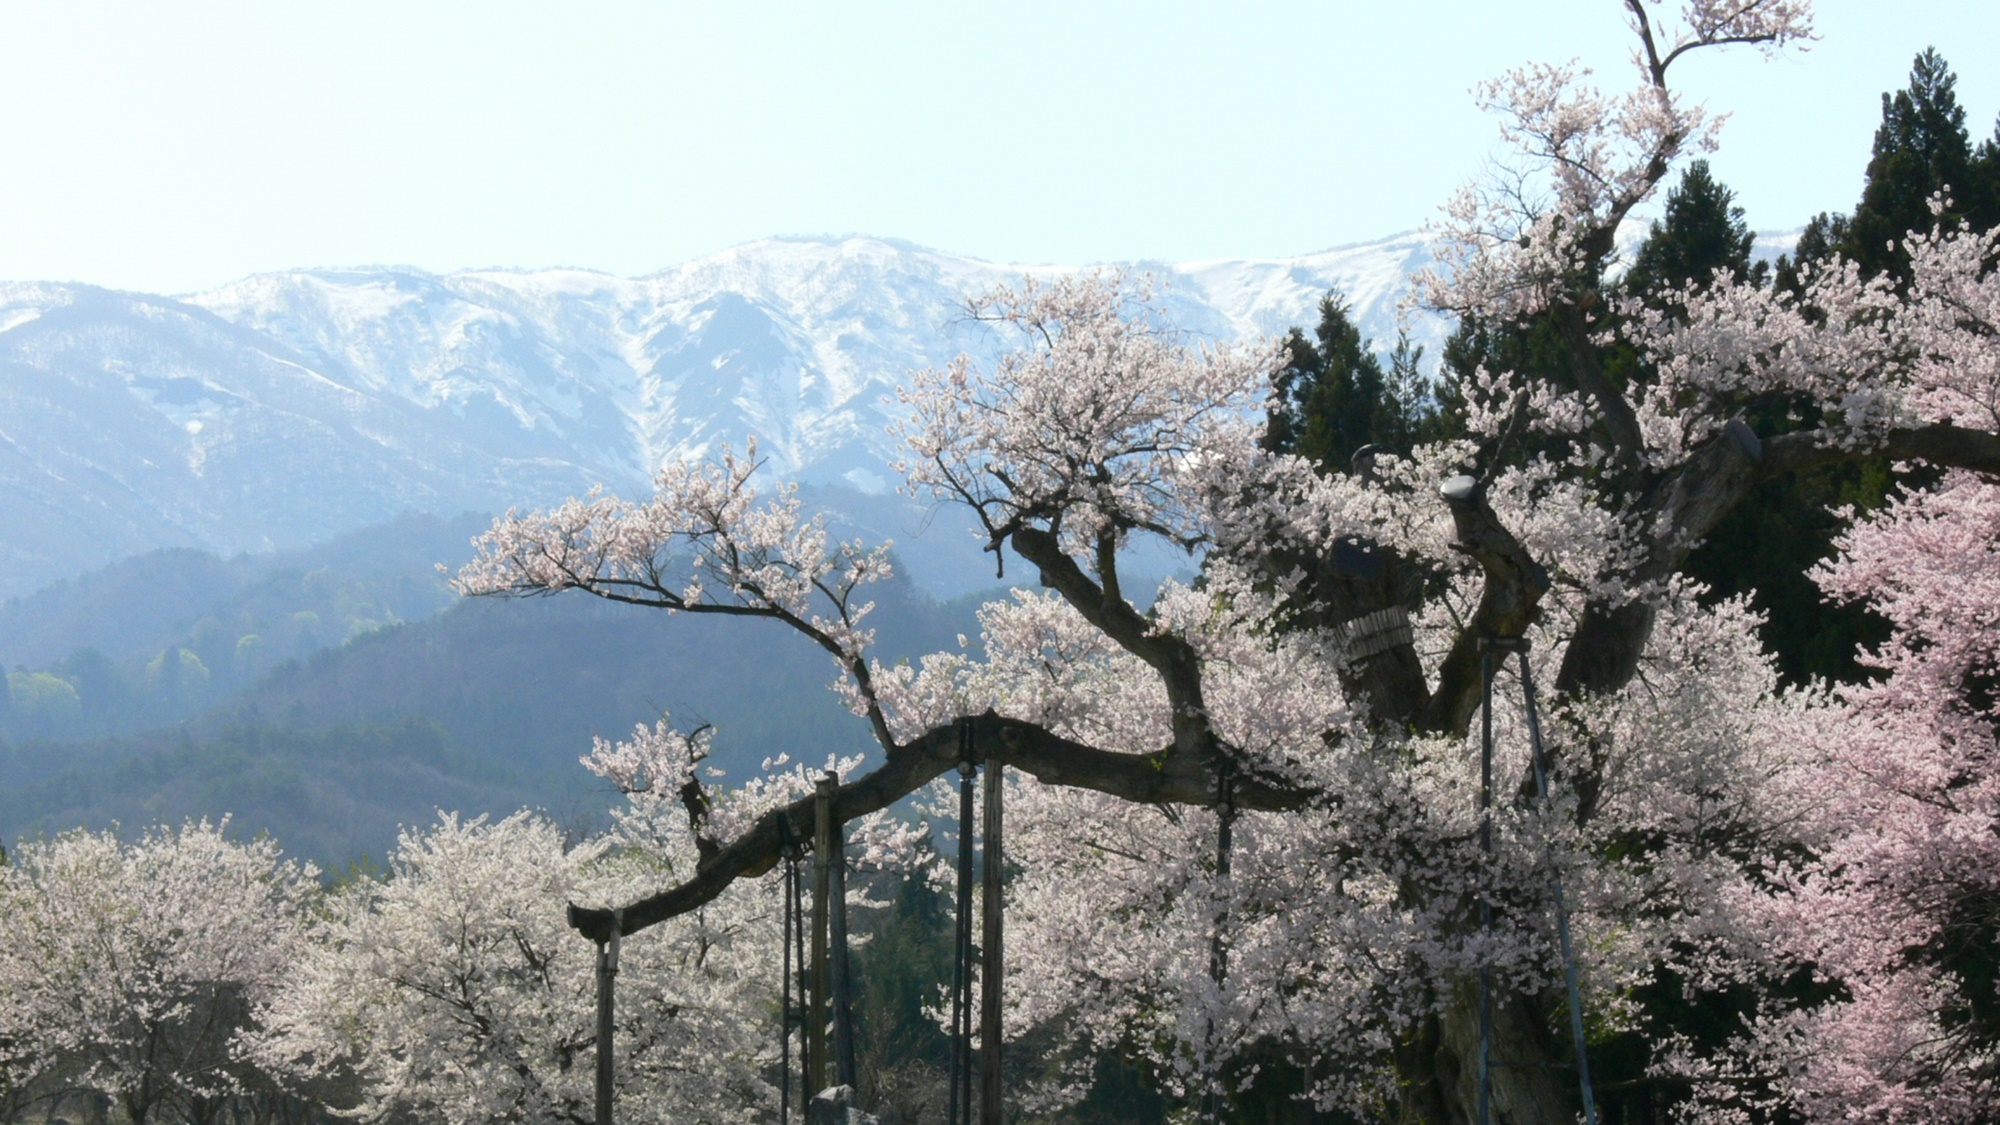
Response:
[252,804,778,1123]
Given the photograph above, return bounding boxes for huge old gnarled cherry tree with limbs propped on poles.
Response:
[458,0,2000,1123]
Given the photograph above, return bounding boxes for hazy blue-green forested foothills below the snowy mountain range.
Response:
[0,532,984,865]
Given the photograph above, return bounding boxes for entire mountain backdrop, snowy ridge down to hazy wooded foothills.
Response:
[0,224,1816,861]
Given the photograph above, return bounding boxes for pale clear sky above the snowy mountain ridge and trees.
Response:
[0,0,2000,292]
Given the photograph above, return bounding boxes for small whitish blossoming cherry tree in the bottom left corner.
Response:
[0,821,316,1125]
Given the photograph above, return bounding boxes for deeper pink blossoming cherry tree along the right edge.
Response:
[1664,217,2000,1121]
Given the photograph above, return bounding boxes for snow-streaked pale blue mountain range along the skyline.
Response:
[0,234,1438,595]
